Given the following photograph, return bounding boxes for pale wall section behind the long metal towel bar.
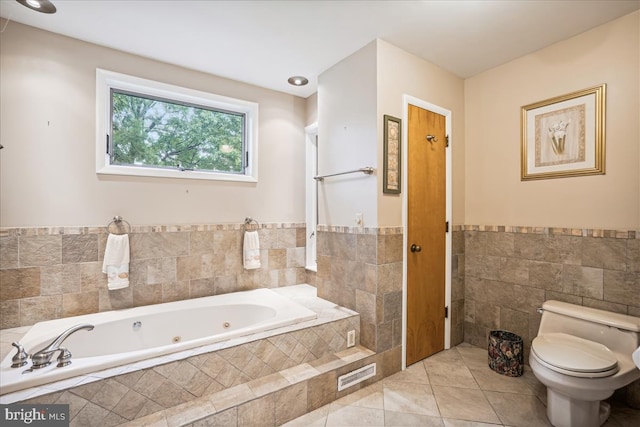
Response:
[318,41,378,227]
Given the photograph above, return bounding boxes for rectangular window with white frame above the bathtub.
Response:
[96,69,258,182]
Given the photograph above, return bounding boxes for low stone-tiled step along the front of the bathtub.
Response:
[123,347,398,427]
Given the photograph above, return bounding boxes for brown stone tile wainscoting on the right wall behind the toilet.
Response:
[457,226,640,360]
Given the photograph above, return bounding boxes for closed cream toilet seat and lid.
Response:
[531,333,620,378]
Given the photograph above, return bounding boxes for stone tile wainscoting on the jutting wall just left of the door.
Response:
[316,226,403,353]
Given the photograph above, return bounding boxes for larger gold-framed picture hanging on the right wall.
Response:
[521,84,606,181]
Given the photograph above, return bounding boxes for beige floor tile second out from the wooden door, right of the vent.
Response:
[383,381,440,416]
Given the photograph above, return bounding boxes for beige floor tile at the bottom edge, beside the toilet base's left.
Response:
[485,391,551,427]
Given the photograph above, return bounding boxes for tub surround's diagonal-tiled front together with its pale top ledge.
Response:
[0,285,360,427]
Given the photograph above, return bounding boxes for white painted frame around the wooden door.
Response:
[402,95,452,369]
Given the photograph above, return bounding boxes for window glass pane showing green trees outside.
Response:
[111,89,246,174]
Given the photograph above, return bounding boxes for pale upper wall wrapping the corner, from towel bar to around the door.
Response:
[318,40,464,227]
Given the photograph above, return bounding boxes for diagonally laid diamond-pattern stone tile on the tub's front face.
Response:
[23,316,360,427]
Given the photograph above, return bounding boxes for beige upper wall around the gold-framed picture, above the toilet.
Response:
[465,12,640,229]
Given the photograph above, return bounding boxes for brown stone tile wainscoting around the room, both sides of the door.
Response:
[5,224,640,368]
